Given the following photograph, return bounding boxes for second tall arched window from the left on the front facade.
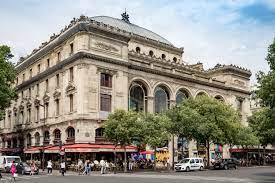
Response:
[155,86,169,113]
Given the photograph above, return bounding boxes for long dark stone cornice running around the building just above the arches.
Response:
[16,52,250,94]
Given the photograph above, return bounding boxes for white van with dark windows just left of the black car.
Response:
[175,158,204,172]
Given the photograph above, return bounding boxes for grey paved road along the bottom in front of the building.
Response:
[1,167,275,183]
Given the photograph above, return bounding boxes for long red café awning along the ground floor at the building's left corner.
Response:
[24,144,137,153]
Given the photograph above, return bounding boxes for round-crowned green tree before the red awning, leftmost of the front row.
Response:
[104,109,142,172]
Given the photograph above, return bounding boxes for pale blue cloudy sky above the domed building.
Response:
[0,0,275,82]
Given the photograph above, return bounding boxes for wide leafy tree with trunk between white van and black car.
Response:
[182,96,240,166]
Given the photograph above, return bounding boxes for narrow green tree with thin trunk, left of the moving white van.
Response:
[141,113,171,170]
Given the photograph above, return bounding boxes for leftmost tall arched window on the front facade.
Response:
[129,82,147,111]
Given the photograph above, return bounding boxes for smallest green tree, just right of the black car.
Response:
[236,126,260,166]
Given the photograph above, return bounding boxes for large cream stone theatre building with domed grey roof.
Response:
[0,13,251,163]
